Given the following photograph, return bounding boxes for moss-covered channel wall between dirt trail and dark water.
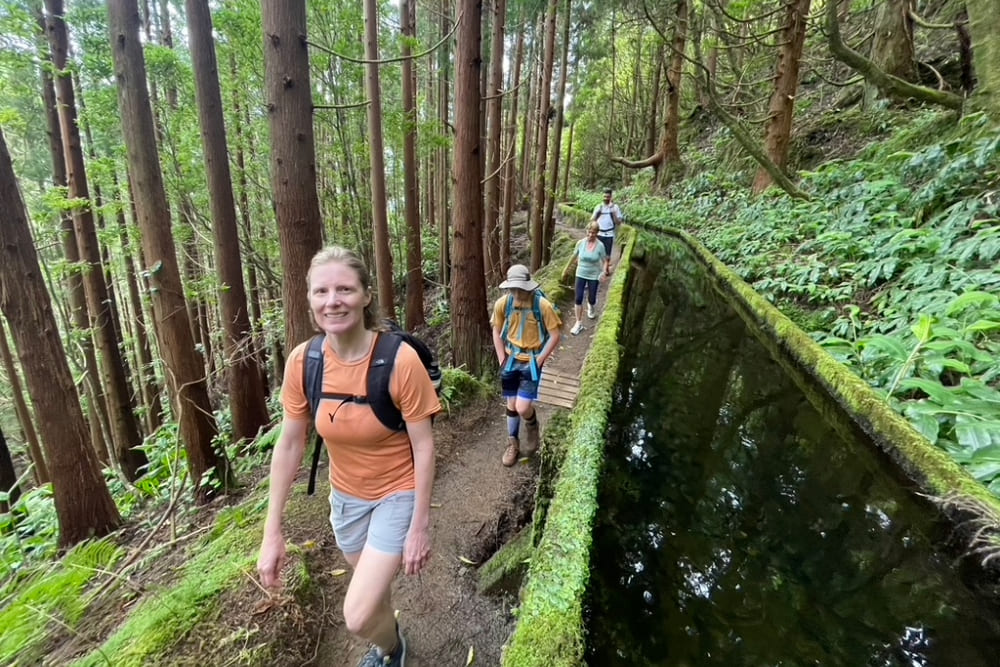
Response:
[502,207,635,667]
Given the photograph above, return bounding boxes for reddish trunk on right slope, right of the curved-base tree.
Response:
[753,0,809,193]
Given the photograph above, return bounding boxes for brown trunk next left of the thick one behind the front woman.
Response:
[185,0,268,440]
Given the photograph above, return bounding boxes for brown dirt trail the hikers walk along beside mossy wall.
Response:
[288,228,618,667]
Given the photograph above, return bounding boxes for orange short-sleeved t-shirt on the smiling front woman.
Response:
[281,339,441,500]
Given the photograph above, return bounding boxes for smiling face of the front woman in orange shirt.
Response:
[309,262,372,335]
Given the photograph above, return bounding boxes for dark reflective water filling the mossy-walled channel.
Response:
[586,240,1000,667]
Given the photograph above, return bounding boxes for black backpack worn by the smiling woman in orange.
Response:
[302,320,441,496]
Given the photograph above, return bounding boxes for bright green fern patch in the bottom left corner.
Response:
[0,539,124,665]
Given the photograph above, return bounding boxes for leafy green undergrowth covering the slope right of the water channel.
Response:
[578,113,1000,495]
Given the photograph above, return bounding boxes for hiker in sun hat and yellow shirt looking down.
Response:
[492,264,562,466]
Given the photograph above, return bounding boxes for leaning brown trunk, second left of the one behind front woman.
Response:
[108,0,230,501]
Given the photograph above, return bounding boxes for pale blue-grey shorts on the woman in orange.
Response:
[330,489,416,555]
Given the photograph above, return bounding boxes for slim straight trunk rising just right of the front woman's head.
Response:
[364,0,396,319]
